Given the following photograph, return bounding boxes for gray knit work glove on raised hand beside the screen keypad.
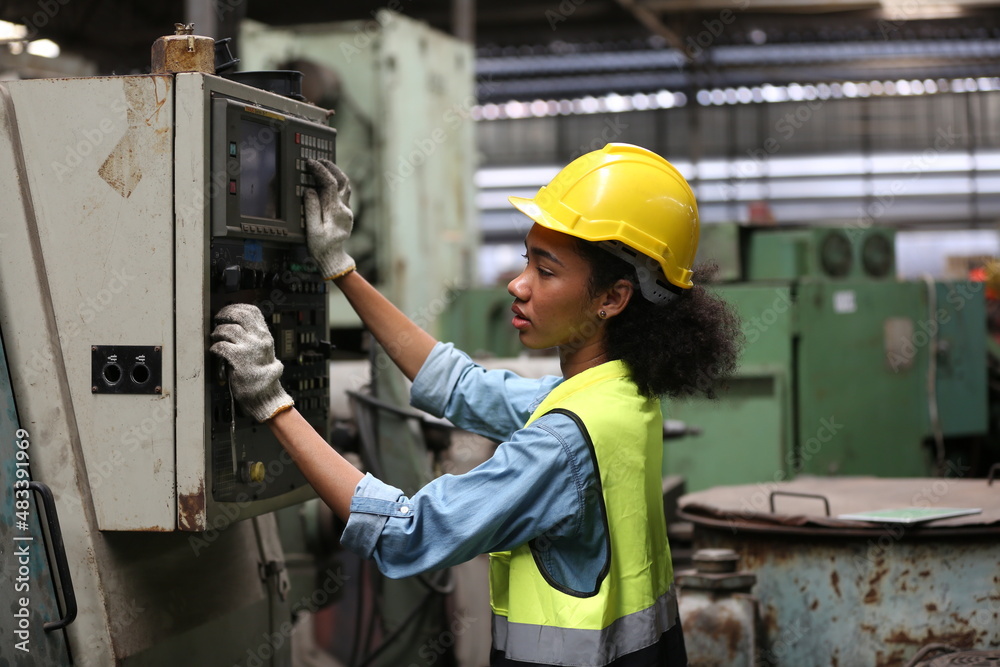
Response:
[305,160,355,280]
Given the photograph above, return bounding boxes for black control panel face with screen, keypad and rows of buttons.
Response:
[206,92,336,502]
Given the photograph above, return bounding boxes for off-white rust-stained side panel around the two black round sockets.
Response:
[5,76,176,531]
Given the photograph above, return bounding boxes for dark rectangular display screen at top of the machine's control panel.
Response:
[240,119,281,219]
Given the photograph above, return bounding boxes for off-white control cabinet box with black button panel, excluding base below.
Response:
[0,73,335,532]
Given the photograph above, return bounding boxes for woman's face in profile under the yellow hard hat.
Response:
[507,225,601,350]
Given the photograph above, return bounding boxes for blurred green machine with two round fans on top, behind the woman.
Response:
[664,224,987,490]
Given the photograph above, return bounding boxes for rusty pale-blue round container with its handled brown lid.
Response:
[680,478,1000,667]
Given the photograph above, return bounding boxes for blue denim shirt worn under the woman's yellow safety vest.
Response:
[341,343,607,591]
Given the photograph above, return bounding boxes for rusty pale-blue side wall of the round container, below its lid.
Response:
[695,527,1000,667]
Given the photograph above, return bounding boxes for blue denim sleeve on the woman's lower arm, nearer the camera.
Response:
[341,415,594,578]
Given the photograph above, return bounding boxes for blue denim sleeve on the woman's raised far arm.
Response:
[410,343,562,441]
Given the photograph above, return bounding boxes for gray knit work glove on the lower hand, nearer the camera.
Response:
[209,303,295,422]
